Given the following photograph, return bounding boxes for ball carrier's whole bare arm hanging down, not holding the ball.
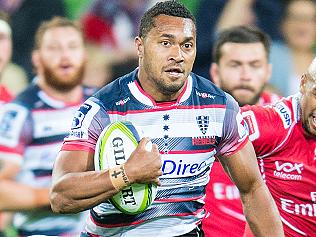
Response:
[220,141,284,237]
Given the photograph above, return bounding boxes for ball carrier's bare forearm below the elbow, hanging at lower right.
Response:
[241,184,284,237]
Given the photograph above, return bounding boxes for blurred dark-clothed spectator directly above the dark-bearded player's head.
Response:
[193,0,283,78]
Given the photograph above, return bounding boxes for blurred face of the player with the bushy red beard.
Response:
[38,27,85,91]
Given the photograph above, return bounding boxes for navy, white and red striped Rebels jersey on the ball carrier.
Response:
[62,70,248,237]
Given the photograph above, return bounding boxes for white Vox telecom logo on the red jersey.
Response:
[273,161,304,180]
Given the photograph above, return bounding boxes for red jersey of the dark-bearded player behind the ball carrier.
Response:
[202,91,281,237]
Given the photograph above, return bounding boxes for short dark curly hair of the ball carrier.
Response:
[139,0,196,37]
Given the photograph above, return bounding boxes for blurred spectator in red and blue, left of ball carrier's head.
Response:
[82,0,149,60]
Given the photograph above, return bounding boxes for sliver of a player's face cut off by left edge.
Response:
[0,31,12,72]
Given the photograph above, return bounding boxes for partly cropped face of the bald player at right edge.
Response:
[300,75,316,137]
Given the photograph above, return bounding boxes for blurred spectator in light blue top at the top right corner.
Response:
[270,0,316,96]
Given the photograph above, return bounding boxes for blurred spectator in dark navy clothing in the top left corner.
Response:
[0,0,65,80]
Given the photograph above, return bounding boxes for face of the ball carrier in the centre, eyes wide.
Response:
[135,15,196,100]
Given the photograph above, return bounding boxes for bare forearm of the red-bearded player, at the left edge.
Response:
[0,180,49,211]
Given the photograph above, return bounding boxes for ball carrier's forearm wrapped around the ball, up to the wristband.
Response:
[50,171,117,213]
